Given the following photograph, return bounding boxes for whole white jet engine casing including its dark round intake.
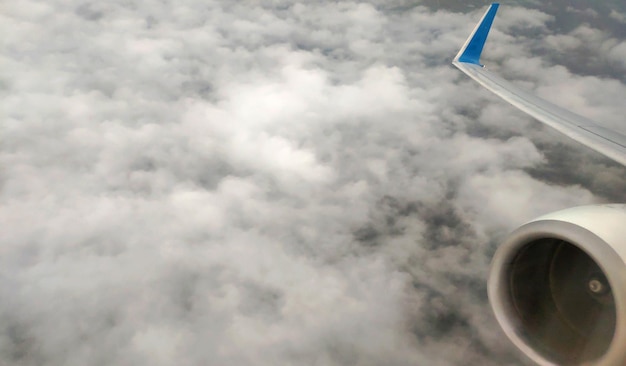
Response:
[488,205,626,366]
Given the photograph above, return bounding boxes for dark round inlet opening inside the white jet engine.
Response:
[507,238,616,364]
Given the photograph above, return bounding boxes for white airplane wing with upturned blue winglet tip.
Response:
[452,3,626,166]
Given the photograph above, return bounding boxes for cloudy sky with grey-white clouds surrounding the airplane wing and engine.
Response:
[0,0,626,366]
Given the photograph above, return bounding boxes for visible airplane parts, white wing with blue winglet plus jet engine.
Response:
[452,3,626,366]
